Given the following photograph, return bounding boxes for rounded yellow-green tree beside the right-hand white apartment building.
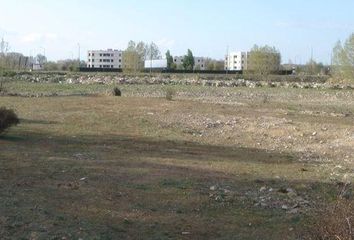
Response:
[247,45,281,75]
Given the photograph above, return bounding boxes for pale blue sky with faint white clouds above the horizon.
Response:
[0,0,354,63]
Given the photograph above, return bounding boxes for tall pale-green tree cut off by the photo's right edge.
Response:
[332,34,354,81]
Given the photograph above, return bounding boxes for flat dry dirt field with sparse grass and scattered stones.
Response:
[0,83,354,239]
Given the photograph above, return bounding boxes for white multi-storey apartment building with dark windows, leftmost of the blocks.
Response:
[87,49,123,68]
